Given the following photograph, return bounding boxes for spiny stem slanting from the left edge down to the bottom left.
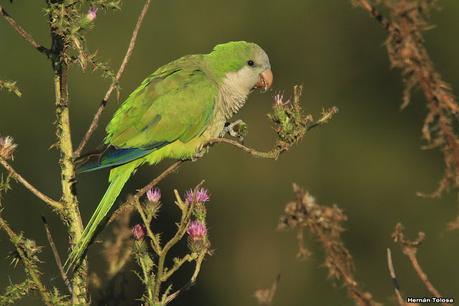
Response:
[0,217,53,306]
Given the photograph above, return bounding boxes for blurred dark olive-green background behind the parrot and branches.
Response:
[0,0,459,306]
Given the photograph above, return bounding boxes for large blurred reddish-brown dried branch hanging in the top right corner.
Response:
[354,0,459,201]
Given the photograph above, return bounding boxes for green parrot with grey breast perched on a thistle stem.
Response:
[65,41,273,271]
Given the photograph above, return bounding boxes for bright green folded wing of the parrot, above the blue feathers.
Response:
[105,55,218,148]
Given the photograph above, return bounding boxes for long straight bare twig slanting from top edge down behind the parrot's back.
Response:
[74,0,151,157]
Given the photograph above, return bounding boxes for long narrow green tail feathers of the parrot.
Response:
[64,159,142,273]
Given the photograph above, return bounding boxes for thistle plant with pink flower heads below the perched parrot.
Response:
[132,184,211,306]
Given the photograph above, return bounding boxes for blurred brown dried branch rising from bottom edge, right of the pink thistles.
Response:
[278,184,380,306]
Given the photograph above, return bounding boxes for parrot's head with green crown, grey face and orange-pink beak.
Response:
[207,41,273,93]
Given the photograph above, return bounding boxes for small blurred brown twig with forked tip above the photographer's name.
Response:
[392,223,447,306]
